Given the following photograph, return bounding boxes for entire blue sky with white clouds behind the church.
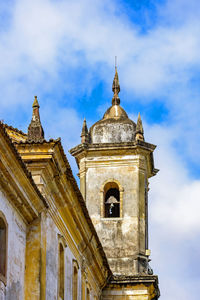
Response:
[0,0,200,300]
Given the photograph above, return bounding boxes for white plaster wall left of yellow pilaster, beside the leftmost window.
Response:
[0,191,26,300]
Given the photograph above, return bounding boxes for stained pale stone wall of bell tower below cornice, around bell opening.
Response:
[80,155,146,274]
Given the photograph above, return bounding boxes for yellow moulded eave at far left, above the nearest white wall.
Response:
[0,123,47,223]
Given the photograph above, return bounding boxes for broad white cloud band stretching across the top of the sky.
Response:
[0,0,200,95]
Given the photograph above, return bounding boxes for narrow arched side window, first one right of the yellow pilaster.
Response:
[58,243,65,300]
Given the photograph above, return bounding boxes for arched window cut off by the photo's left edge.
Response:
[0,212,7,283]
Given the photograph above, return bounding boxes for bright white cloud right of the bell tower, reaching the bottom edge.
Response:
[144,124,200,300]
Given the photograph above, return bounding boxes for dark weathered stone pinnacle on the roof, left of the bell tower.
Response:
[28,96,44,143]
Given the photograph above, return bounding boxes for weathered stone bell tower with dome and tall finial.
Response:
[70,68,158,276]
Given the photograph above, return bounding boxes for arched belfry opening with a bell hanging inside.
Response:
[104,182,120,218]
